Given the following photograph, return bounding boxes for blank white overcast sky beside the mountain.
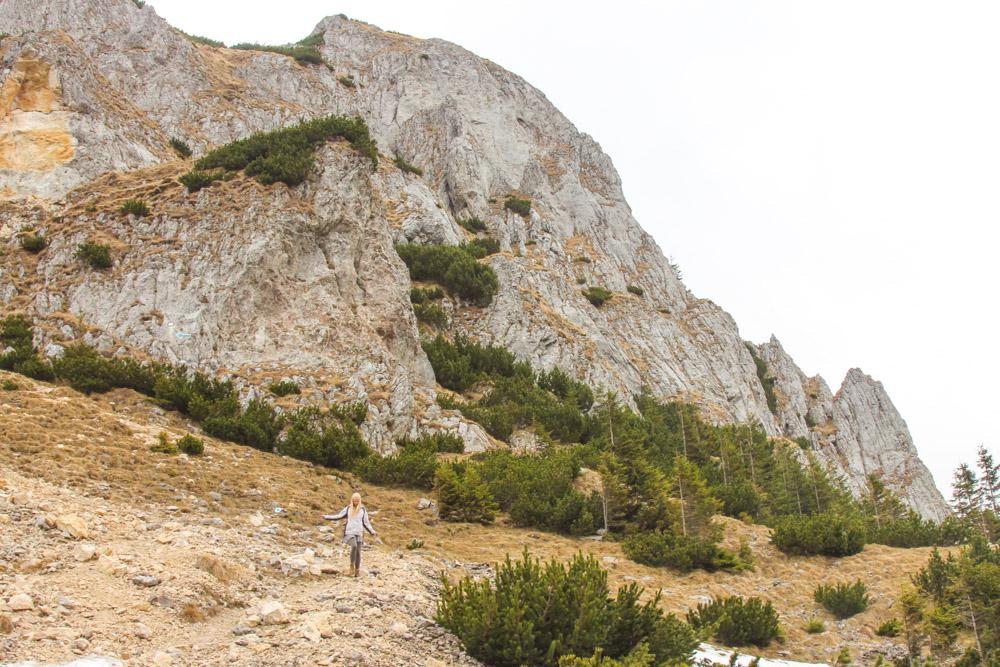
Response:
[152,0,1000,500]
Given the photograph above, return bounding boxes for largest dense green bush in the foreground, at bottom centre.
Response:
[435,551,697,667]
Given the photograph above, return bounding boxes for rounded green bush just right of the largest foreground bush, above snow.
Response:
[687,595,780,647]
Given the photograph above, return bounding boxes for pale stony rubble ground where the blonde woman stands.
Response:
[0,469,476,666]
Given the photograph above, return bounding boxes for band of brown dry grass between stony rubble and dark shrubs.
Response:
[0,372,930,661]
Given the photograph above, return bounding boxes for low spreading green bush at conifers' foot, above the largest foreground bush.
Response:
[622,530,740,572]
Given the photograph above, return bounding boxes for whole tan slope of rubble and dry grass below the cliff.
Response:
[0,372,929,665]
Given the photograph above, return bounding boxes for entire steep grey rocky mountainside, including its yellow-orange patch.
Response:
[0,0,947,517]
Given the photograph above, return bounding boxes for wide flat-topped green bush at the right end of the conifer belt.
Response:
[771,512,866,556]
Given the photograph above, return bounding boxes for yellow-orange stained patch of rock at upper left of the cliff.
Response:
[0,58,76,171]
